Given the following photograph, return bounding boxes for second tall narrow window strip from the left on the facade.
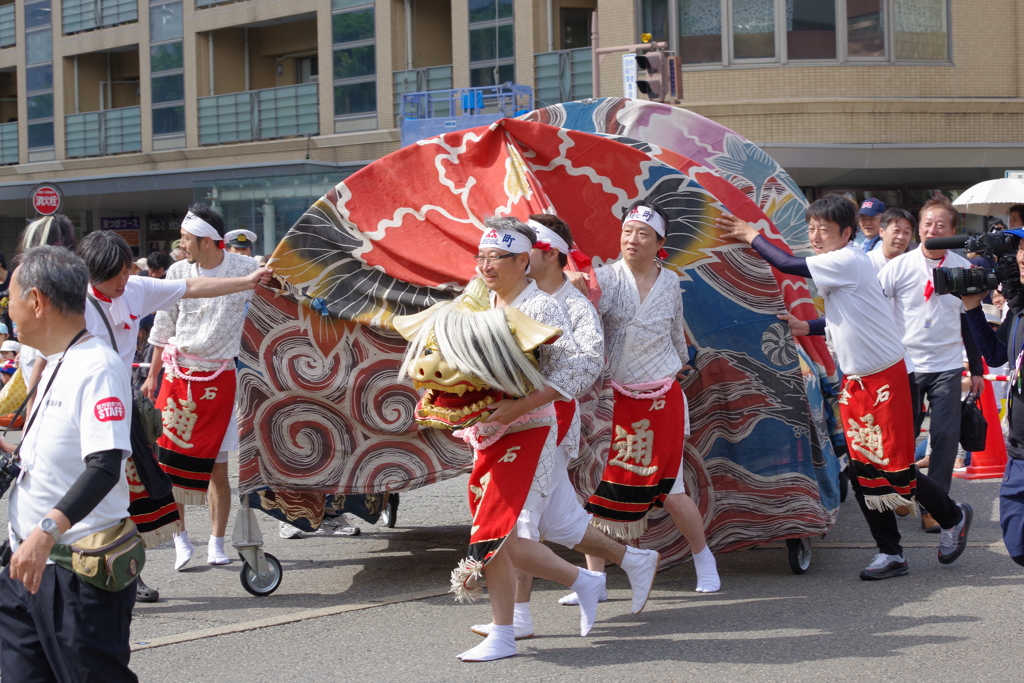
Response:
[150,0,185,141]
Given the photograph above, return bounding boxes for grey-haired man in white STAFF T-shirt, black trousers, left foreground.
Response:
[0,247,141,683]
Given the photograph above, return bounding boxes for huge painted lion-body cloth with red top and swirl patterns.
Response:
[239,114,837,564]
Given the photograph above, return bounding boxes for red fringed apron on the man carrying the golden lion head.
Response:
[451,416,556,601]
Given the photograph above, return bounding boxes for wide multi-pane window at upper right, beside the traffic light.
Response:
[638,0,950,67]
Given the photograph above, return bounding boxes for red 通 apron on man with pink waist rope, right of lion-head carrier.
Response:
[586,378,686,542]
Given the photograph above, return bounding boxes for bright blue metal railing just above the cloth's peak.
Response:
[401,83,534,119]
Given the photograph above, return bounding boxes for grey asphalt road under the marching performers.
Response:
[2,454,1024,683]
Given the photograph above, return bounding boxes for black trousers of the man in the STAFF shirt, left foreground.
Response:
[0,564,138,683]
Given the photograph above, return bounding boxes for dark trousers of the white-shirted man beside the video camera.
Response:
[910,368,963,494]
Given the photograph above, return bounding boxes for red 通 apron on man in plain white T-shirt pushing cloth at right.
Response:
[839,360,918,512]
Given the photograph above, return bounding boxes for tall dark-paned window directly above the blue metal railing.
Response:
[469,0,515,88]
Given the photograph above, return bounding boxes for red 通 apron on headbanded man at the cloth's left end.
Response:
[157,369,238,505]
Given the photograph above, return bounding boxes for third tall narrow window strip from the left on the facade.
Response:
[331,0,377,126]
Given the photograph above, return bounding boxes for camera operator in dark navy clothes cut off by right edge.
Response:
[964,228,1024,566]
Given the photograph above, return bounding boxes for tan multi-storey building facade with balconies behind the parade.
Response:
[0,0,1024,254]
